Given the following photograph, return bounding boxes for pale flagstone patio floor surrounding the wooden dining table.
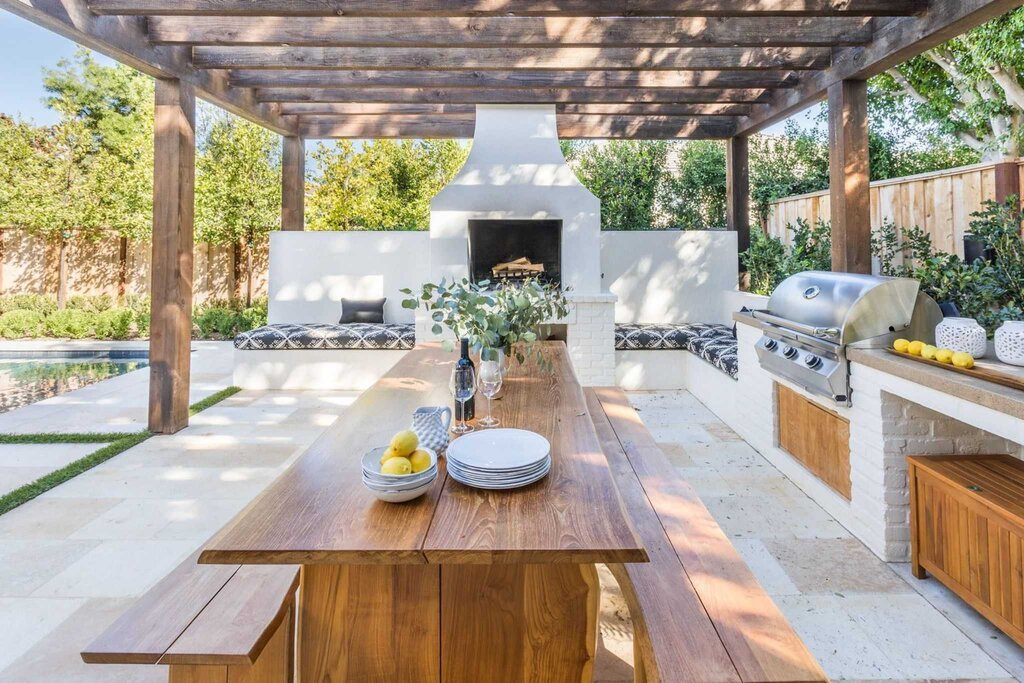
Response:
[0,344,1024,683]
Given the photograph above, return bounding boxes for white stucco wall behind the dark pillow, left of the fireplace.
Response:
[269,231,430,324]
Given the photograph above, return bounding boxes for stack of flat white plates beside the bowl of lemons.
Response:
[445,429,551,489]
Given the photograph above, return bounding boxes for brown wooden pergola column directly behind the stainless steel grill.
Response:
[828,81,871,273]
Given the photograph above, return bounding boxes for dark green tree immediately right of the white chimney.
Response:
[562,140,669,230]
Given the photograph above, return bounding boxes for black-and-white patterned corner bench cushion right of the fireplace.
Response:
[615,323,739,378]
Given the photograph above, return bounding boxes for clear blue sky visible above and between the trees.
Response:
[0,9,810,133]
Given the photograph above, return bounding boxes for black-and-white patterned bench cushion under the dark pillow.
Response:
[234,323,416,351]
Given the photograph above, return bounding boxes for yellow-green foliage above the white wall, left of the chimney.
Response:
[307,140,469,230]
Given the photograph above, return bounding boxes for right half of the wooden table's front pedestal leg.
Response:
[441,564,601,683]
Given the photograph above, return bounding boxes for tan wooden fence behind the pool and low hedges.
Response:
[0,227,267,302]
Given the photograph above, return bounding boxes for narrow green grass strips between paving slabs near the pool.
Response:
[0,387,242,515]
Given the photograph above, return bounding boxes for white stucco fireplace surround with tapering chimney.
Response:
[430,104,601,295]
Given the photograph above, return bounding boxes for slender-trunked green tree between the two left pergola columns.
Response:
[196,112,281,306]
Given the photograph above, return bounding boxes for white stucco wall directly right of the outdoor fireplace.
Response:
[601,230,739,324]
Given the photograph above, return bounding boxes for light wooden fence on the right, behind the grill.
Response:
[768,160,1024,256]
